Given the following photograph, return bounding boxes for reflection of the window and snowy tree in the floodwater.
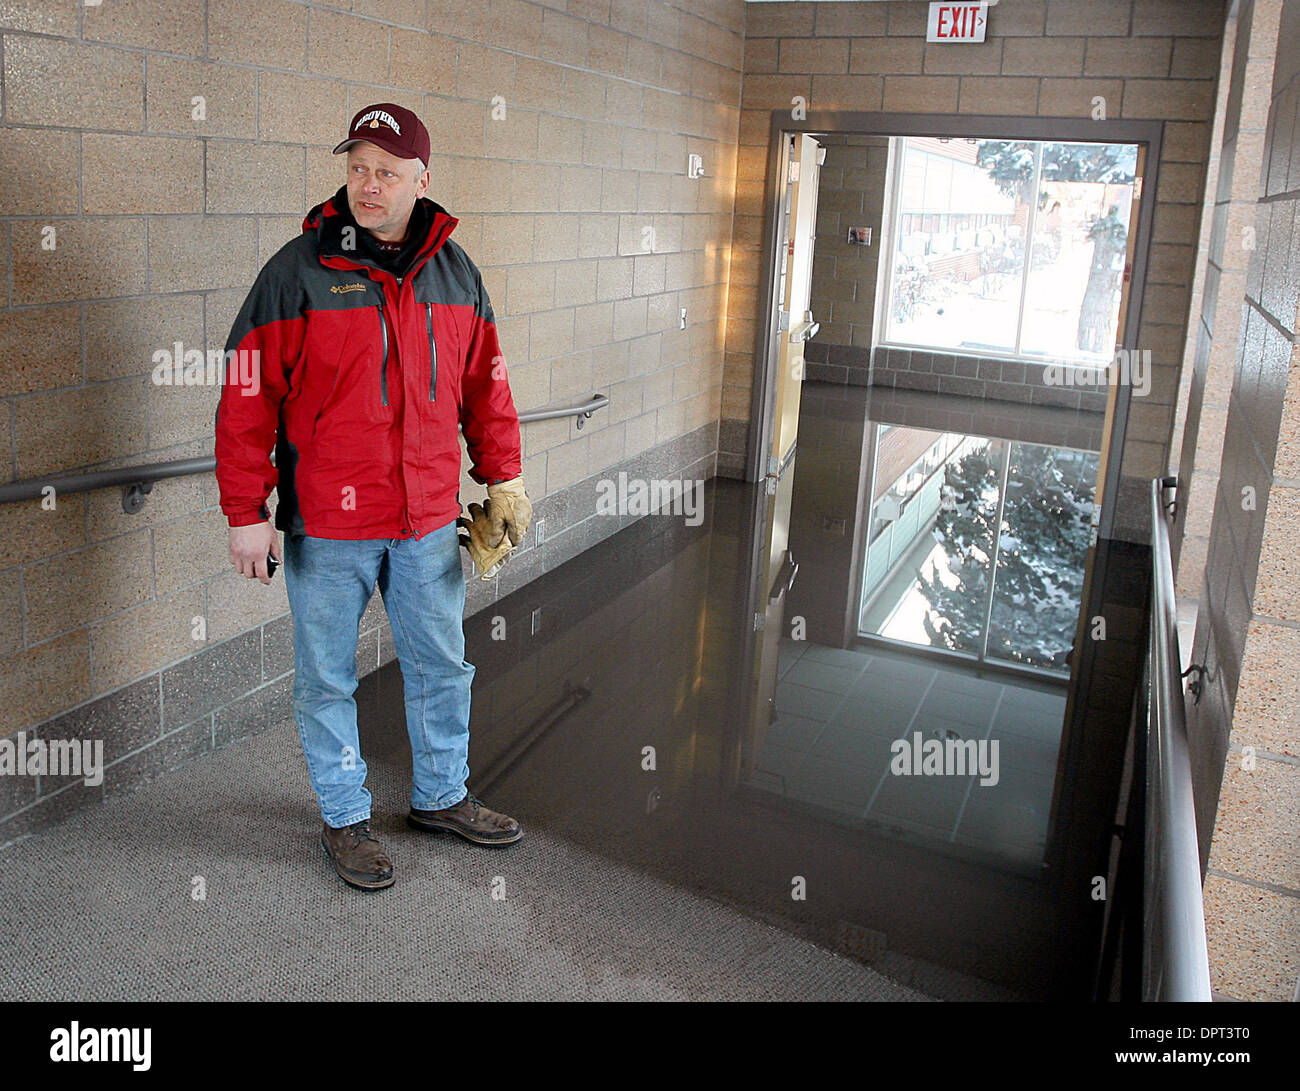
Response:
[859,425,1099,676]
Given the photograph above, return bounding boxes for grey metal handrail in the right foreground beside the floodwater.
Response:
[1141,477,1213,1001]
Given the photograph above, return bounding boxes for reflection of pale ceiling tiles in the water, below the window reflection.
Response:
[753,641,1065,875]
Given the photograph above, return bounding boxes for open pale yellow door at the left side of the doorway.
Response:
[767,133,826,473]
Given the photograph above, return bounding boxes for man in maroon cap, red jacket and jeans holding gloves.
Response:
[216,103,532,889]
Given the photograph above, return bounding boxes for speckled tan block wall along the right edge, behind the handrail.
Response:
[1187,0,1300,1000]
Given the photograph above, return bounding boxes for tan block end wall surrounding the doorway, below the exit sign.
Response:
[719,0,1225,541]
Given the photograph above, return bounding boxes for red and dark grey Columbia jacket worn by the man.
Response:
[216,186,521,538]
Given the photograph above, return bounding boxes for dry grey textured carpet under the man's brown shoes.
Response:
[0,724,930,1000]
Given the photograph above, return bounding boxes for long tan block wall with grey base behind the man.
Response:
[0,0,744,844]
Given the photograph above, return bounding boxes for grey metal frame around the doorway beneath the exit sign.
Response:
[745,109,1165,538]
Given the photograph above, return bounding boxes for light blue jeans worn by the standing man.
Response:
[285,521,475,828]
